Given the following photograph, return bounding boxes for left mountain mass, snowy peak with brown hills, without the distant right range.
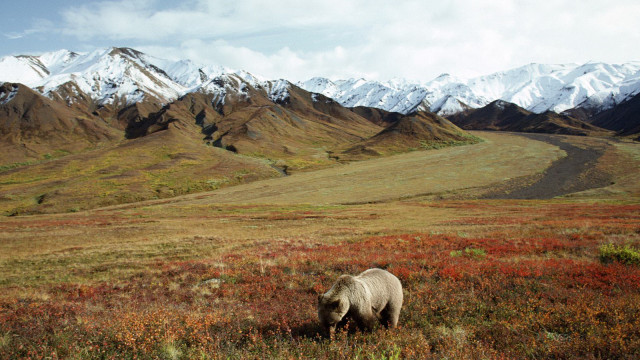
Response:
[0,48,480,170]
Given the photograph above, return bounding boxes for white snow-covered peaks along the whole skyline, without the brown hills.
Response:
[0,48,640,116]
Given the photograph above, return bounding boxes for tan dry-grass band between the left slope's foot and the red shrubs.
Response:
[0,204,460,292]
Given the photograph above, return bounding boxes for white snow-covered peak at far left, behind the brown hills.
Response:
[0,48,187,104]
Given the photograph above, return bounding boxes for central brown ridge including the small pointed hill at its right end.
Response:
[127,75,480,170]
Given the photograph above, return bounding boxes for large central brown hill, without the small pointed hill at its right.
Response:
[126,76,382,169]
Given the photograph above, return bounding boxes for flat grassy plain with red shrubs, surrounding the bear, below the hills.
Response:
[0,134,640,359]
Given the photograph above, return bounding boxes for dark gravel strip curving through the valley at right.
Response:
[483,134,612,199]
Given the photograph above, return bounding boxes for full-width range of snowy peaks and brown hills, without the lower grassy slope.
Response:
[0,48,640,167]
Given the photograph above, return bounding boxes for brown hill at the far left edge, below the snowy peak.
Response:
[0,83,122,164]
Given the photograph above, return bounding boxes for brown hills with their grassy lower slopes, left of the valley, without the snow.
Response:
[0,75,482,214]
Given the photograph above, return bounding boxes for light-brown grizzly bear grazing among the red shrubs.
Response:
[318,269,402,336]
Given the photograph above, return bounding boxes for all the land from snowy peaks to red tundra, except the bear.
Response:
[0,48,640,359]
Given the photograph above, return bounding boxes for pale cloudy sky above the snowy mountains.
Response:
[0,0,640,81]
